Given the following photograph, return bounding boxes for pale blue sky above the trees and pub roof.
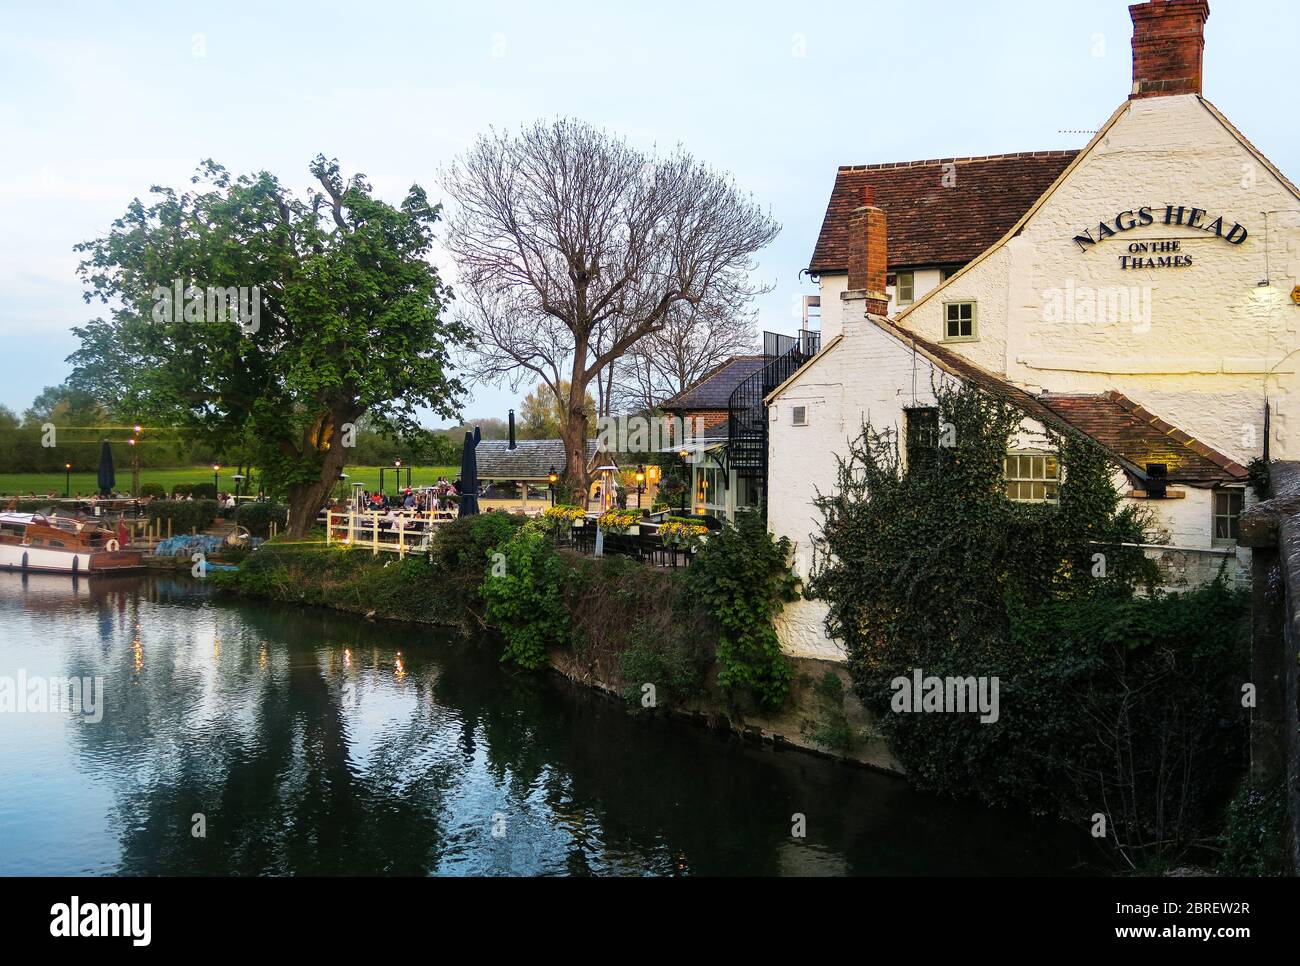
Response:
[0,0,1300,416]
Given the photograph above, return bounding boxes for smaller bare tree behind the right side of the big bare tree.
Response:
[611,302,758,411]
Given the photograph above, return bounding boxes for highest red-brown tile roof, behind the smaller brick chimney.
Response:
[809,151,1079,274]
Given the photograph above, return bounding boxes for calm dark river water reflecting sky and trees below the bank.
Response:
[0,575,1089,875]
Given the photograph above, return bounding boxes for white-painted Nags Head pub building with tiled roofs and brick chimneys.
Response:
[766,0,1300,658]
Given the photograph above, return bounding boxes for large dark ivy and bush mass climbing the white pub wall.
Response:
[809,386,1247,863]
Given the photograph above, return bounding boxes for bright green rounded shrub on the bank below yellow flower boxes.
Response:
[481,527,568,671]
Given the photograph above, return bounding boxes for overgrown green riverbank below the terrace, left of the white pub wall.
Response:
[213,508,816,714]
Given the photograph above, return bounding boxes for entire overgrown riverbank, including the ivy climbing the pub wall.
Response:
[215,390,1277,871]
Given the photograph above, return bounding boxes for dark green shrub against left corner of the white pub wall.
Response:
[689,511,796,710]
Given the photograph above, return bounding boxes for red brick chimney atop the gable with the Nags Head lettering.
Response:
[1128,0,1210,99]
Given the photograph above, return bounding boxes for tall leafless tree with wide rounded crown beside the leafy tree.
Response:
[442,118,780,488]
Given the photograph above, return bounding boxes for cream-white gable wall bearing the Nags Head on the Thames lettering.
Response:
[898,95,1300,463]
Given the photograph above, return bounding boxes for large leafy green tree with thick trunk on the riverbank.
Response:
[70,156,468,537]
